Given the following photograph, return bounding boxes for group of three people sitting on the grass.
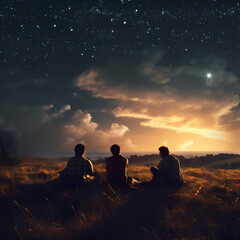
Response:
[60,144,184,189]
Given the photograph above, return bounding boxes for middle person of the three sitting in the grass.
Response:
[106,144,131,190]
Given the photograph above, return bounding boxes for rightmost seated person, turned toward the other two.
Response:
[150,146,184,188]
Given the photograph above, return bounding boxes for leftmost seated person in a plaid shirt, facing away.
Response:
[59,144,93,186]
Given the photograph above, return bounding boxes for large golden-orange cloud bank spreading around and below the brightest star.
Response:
[75,52,239,143]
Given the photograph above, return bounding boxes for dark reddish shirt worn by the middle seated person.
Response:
[106,155,128,186]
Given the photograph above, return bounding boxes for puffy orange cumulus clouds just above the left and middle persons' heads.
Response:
[63,109,136,151]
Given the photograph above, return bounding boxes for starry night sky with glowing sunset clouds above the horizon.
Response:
[0,0,240,154]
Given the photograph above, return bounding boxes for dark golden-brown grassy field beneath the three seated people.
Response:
[0,159,240,240]
